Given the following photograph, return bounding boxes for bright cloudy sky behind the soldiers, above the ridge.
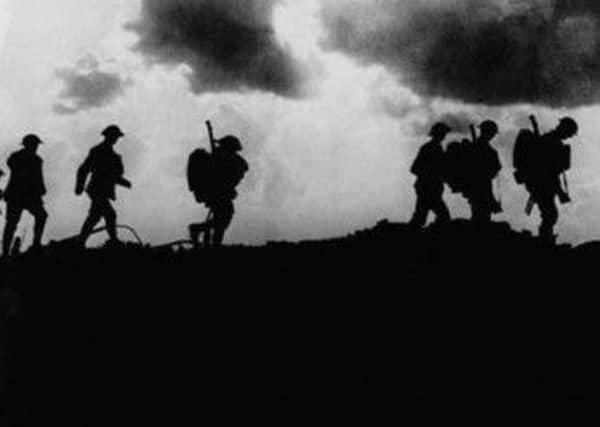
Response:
[0,0,600,243]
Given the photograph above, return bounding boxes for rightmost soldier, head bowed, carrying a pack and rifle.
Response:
[513,116,578,243]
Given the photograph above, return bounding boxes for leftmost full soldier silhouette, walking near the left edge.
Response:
[2,135,48,256]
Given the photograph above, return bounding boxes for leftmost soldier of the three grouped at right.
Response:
[410,123,451,228]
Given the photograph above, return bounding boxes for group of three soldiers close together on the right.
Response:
[410,116,578,242]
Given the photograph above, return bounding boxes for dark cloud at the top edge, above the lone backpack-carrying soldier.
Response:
[128,0,302,97]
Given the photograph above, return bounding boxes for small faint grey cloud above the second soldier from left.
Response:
[53,69,130,114]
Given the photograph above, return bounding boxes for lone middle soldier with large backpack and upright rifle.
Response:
[187,122,248,246]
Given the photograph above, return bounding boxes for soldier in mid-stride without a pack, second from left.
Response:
[75,125,131,245]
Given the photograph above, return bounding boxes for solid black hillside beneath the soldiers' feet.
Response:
[0,221,600,426]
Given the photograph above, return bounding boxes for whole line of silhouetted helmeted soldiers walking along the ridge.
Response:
[2,117,578,255]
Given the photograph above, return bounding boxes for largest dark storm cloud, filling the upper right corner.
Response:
[323,0,600,107]
